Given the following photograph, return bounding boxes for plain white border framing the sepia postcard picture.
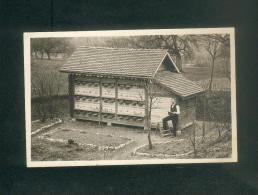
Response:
[24,27,238,167]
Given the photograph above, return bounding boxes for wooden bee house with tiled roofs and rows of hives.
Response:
[60,47,203,132]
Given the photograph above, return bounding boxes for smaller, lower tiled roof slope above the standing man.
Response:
[155,71,204,98]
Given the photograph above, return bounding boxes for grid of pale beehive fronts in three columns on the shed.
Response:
[74,81,145,125]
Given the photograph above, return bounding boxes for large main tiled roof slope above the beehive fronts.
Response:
[60,47,168,77]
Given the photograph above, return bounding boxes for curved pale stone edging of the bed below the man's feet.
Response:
[133,139,193,158]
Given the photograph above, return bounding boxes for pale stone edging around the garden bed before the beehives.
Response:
[38,130,134,151]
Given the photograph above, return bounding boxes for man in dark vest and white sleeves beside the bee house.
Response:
[162,99,180,136]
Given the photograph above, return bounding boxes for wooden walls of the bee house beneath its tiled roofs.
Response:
[69,74,195,129]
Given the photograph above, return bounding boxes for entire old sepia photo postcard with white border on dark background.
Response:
[24,28,237,167]
